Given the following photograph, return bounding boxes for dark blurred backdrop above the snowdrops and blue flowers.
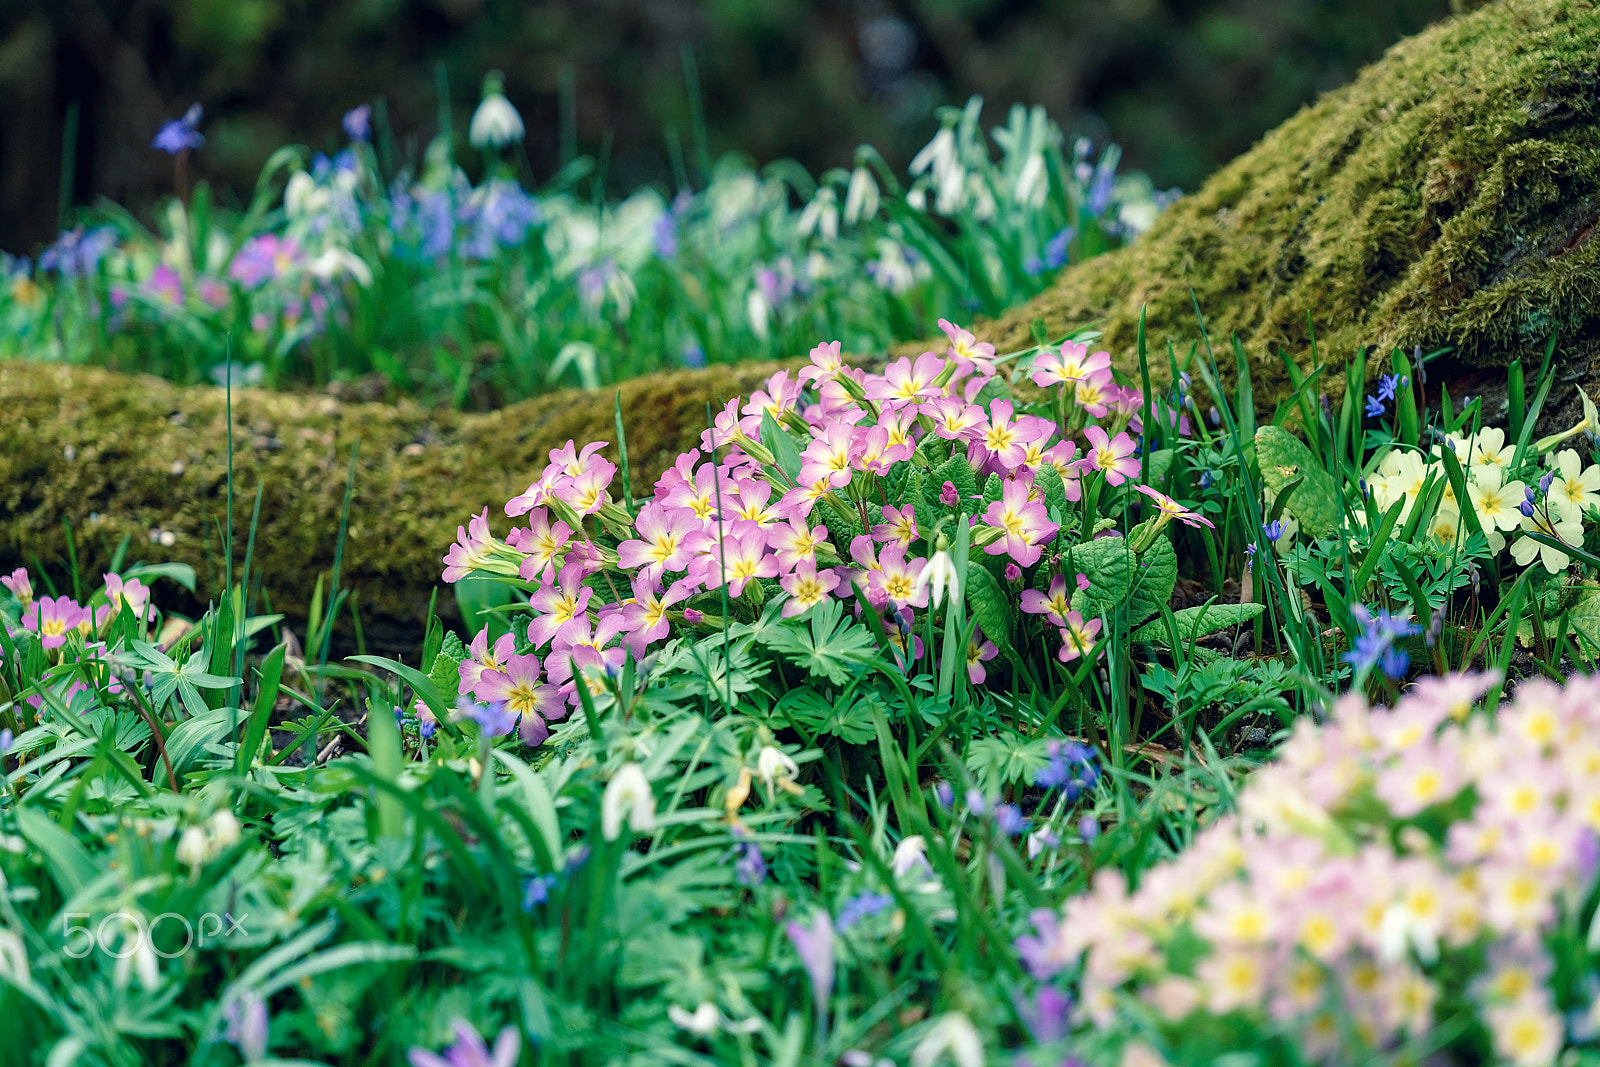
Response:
[0,0,1459,253]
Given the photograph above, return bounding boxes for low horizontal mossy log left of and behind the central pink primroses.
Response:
[0,360,779,651]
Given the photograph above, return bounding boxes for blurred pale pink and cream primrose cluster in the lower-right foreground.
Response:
[1018,675,1600,1067]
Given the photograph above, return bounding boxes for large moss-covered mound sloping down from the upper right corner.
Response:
[978,0,1600,400]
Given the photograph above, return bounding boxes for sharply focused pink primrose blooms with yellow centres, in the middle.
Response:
[443,323,1184,734]
